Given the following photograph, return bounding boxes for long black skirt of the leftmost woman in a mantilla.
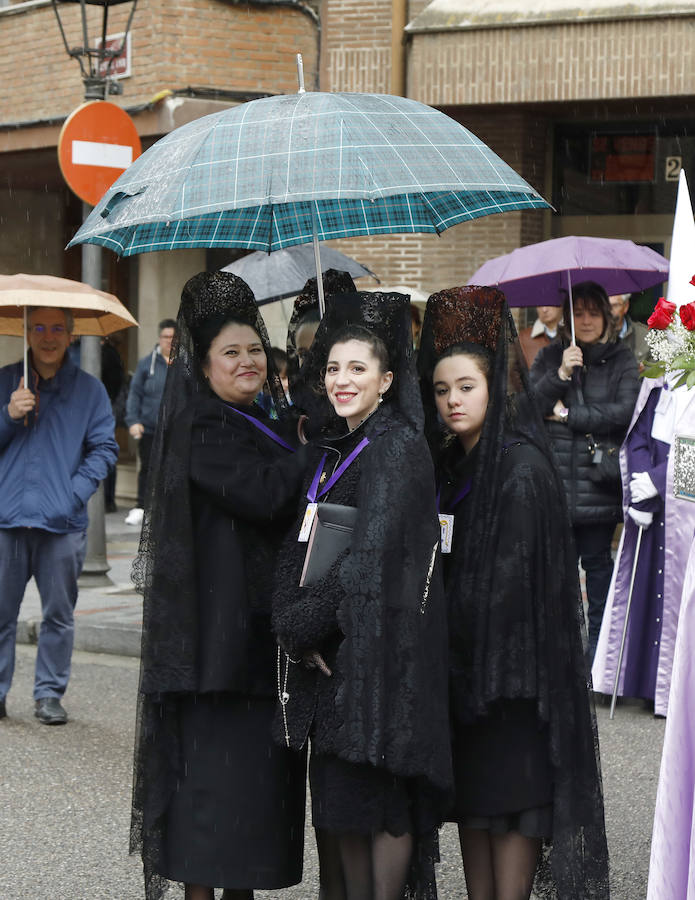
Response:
[158,694,306,890]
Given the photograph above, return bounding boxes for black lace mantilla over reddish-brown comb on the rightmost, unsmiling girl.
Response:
[418,286,609,900]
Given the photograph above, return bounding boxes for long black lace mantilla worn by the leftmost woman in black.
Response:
[130,272,298,900]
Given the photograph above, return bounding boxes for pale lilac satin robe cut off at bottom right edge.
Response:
[647,544,695,900]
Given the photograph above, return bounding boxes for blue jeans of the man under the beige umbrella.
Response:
[0,528,87,700]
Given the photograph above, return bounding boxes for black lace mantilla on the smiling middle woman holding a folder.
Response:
[292,291,452,900]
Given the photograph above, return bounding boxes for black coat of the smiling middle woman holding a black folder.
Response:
[273,404,451,790]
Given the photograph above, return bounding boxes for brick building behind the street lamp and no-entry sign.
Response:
[0,0,320,362]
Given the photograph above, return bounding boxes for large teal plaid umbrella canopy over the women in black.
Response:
[69,92,548,256]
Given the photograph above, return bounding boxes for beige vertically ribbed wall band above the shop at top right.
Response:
[408,15,695,105]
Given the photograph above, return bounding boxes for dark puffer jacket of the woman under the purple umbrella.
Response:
[531,340,639,524]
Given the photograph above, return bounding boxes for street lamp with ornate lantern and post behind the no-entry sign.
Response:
[52,0,137,586]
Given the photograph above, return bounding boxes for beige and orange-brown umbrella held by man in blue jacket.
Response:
[0,275,138,384]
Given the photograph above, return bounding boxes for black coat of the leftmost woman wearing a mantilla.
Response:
[142,396,304,696]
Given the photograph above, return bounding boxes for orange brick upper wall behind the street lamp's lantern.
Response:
[0,0,318,126]
